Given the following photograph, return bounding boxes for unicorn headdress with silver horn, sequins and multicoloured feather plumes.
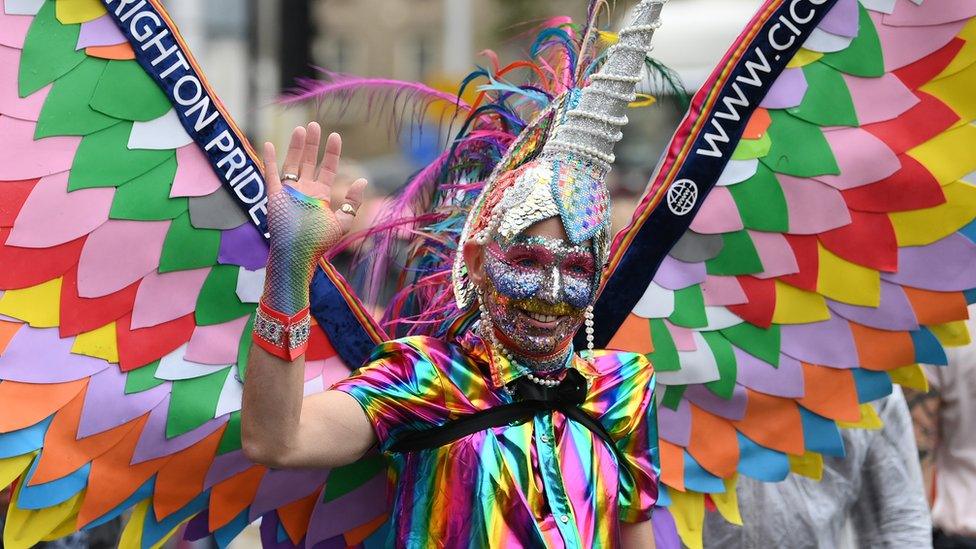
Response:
[296,0,684,337]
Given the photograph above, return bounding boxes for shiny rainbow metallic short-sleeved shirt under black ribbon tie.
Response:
[333,331,659,548]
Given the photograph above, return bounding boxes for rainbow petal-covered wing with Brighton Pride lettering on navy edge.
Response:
[0,0,387,548]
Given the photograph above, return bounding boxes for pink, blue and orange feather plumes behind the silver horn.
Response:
[300,1,683,336]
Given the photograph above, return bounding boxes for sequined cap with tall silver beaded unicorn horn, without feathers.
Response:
[451,0,666,310]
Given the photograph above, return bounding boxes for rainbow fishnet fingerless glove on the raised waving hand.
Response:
[261,185,342,316]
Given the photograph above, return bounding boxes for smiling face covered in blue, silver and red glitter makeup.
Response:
[485,234,599,366]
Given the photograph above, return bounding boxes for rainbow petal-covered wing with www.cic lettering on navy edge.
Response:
[597,0,976,546]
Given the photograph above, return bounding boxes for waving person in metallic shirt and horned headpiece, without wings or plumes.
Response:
[242,1,663,548]
